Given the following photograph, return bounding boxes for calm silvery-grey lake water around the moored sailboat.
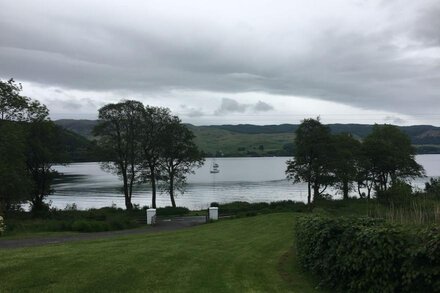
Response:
[48,155,440,209]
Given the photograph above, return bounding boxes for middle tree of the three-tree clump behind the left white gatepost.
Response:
[141,106,177,208]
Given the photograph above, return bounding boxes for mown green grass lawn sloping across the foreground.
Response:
[0,213,316,292]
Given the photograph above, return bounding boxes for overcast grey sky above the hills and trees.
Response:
[0,0,440,125]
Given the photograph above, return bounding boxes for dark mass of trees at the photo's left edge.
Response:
[0,79,68,212]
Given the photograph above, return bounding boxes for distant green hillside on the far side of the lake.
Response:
[55,119,440,156]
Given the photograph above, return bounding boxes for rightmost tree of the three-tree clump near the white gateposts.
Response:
[160,117,204,207]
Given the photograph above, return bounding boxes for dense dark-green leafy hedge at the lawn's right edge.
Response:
[295,216,440,292]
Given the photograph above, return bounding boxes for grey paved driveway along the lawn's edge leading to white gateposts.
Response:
[0,216,206,249]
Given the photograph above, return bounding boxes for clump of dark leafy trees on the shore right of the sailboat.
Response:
[286,119,424,203]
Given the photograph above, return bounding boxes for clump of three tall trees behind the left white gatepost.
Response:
[93,100,204,209]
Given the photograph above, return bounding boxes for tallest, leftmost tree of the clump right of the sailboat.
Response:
[286,119,333,204]
